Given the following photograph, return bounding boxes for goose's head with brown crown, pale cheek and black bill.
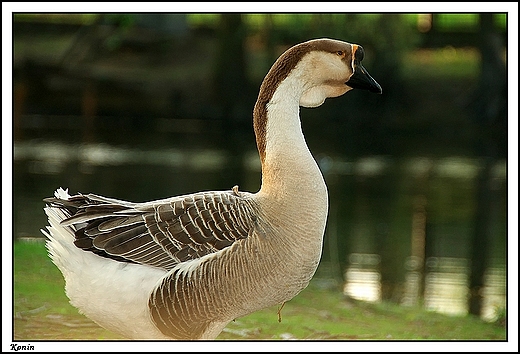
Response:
[264,38,382,107]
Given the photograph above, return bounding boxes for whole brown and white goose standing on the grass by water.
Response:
[41,38,382,340]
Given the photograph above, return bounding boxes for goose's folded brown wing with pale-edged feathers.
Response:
[44,189,256,270]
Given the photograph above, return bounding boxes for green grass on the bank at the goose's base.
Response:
[13,242,506,340]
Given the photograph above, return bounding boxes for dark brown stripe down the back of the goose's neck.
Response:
[253,42,314,164]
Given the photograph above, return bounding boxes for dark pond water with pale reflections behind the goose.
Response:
[13,140,506,320]
